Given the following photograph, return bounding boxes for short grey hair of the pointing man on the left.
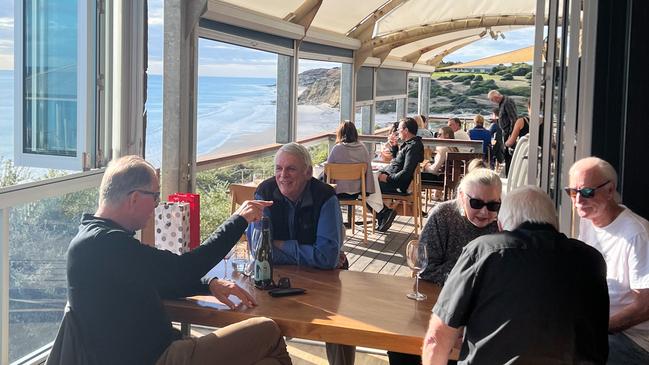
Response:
[99,155,156,206]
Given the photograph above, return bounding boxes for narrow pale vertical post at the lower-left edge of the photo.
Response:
[0,208,11,364]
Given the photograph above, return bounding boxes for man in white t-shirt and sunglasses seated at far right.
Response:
[565,157,649,364]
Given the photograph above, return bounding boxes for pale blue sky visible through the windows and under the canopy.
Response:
[0,0,534,77]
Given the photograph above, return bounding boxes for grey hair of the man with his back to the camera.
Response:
[498,185,559,231]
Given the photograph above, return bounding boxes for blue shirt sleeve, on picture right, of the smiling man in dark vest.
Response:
[273,196,343,269]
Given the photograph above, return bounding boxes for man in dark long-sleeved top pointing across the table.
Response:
[59,156,291,365]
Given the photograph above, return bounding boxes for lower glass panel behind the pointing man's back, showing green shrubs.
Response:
[9,187,98,362]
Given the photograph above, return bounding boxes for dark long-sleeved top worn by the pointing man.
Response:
[67,214,247,365]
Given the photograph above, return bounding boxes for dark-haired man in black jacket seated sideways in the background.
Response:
[376,118,424,232]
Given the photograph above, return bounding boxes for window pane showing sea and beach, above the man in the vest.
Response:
[196,38,277,156]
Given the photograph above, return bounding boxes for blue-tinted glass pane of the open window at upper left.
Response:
[23,1,77,156]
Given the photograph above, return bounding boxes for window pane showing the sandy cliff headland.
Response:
[297,59,341,140]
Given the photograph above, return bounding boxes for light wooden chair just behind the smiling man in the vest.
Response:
[324,163,370,243]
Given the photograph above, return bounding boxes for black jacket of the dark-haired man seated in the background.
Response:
[383,136,424,192]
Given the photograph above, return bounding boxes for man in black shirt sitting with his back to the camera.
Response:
[422,186,608,365]
